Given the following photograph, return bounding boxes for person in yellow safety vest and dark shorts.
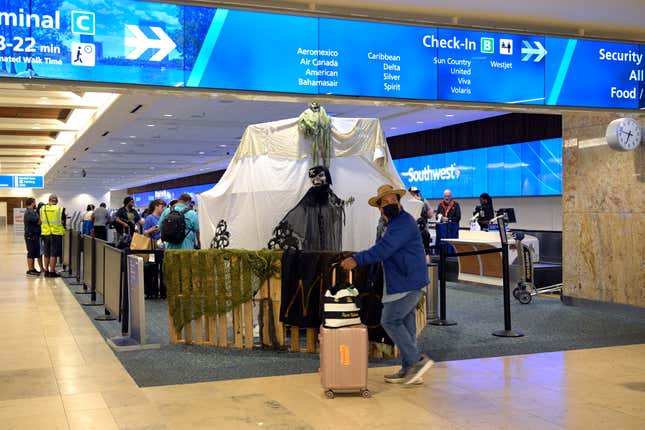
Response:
[40,194,65,278]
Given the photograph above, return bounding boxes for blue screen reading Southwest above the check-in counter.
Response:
[394,138,562,198]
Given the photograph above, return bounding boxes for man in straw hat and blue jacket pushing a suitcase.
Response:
[341,185,434,384]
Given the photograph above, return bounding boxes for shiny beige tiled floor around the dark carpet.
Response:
[0,230,645,430]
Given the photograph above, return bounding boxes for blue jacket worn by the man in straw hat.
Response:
[354,210,429,294]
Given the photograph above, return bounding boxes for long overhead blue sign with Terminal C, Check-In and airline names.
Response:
[0,0,645,109]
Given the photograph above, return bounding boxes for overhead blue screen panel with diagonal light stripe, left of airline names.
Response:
[187,8,320,94]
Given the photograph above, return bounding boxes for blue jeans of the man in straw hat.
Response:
[381,290,422,372]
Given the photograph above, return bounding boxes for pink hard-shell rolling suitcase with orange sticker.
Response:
[318,325,370,399]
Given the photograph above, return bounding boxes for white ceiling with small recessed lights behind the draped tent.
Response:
[45,95,501,191]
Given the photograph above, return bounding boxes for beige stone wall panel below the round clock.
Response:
[562,113,645,307]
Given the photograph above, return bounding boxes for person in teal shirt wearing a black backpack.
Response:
[159,193,199,249]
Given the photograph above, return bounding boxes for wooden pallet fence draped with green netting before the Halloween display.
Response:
[163,249,426,358]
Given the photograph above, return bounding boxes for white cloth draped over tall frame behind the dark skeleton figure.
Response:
[198,118,421,251]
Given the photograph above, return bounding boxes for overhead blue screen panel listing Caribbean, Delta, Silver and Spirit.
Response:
[312,19,437,100]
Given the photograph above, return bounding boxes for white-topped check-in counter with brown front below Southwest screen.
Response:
[444,230,540,286]
